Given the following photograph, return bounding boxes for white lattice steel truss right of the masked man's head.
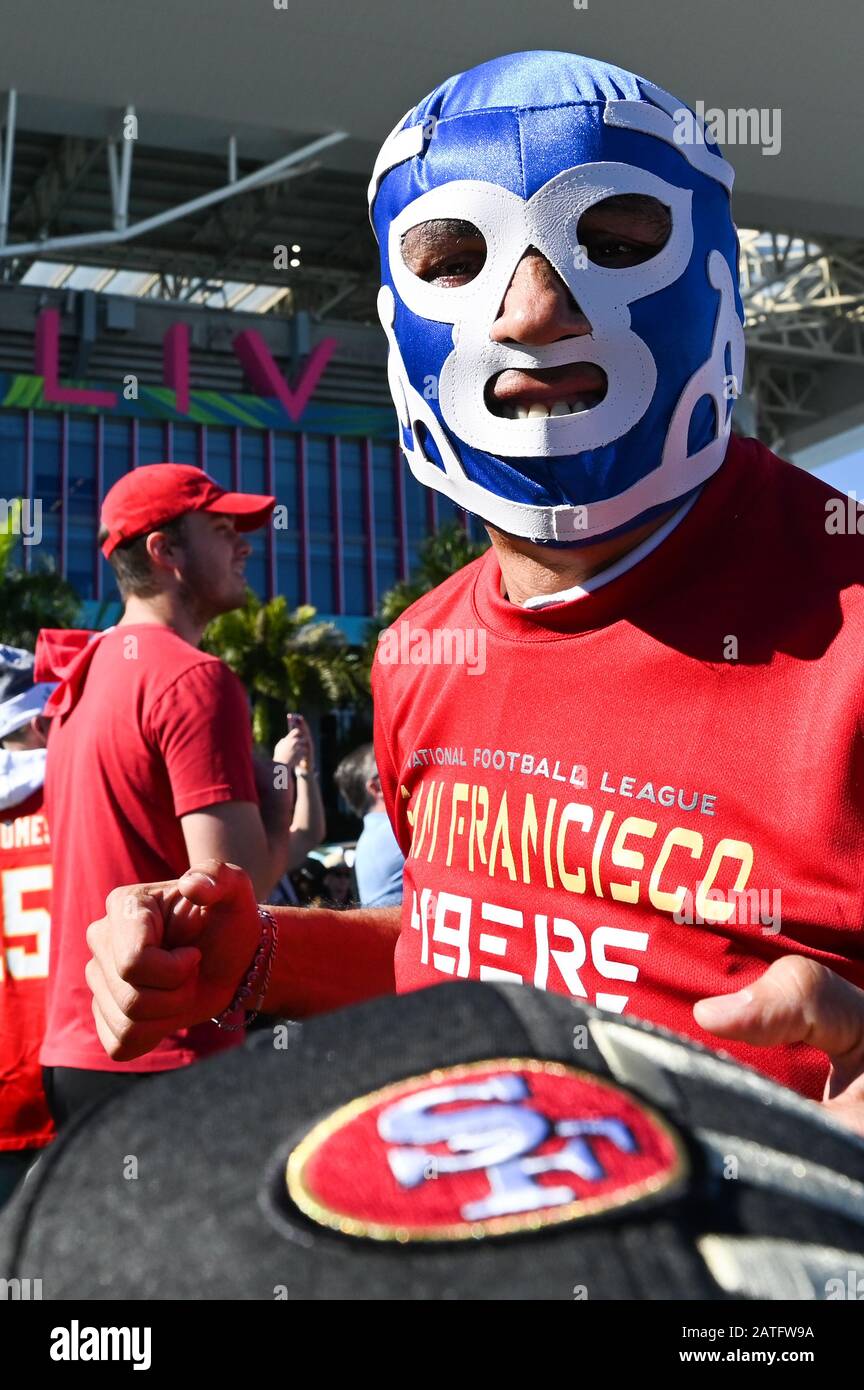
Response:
[739,231,864,449]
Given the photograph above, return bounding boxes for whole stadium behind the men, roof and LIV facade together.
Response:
[0,0,864,635]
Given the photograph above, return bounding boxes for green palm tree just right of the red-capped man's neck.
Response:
[201,591,368,748]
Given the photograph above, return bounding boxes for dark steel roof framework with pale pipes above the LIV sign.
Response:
[0,92,376,321]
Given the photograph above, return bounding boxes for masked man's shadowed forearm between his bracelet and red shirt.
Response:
[264,908,401,1019]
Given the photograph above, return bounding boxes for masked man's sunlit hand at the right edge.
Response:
[693,956,864,1134]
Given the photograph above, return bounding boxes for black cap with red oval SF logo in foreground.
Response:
[0,983,864,1301]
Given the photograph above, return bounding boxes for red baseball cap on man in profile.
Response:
[100,463,276,560]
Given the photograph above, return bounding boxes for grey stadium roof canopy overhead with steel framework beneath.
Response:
[0,0,864,450]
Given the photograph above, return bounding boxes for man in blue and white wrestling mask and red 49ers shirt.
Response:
[88,53,864,1133]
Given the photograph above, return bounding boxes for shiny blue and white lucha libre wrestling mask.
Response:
[369,53,745,545]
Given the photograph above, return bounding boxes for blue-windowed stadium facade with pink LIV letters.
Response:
[0,284,479,635]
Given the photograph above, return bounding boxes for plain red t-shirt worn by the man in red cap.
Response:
[40,624,258,1072]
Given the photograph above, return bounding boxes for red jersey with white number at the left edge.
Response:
[0,792,54,1152]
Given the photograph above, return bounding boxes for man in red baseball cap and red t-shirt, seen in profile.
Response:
[36,463,293,1122]
